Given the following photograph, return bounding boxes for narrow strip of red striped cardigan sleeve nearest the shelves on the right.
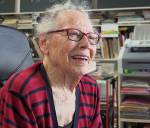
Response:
[89,86,103,128]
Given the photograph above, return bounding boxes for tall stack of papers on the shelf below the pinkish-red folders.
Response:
[120,96,150,119]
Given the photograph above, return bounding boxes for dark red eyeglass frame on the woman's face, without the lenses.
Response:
[47,28,100,45]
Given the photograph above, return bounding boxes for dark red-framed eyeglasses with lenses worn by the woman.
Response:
[47,28,100,45]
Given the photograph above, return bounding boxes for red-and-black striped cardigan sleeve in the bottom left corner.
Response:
[0,87,37,128]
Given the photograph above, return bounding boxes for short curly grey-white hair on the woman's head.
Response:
[36,1,89,35]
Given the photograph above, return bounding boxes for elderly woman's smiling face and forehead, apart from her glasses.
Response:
[42,11,96,76]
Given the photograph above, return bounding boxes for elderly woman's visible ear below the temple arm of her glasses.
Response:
[38,34,48,55]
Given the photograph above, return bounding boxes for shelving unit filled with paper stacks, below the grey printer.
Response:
[118,75,150,128]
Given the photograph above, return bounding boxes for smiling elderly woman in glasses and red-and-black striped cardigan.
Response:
[0,2,102,128]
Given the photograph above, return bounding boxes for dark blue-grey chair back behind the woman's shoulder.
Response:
[0,25,34,86]
